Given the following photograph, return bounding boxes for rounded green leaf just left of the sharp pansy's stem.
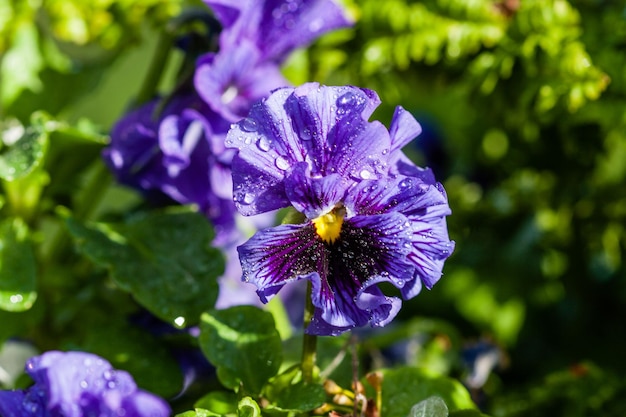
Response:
[200,306,283,394]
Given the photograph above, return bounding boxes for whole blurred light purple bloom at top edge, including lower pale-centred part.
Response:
[194,0,351,122]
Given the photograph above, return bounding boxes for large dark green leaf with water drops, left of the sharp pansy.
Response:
[67,208,224,327]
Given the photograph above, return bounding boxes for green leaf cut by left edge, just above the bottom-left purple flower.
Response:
[0,218,37,312]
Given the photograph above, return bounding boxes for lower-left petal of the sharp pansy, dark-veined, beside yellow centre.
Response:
[237,224,327,303]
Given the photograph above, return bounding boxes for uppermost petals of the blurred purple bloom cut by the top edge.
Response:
[205,0,352,63]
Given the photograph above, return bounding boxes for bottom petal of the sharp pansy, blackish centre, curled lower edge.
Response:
[307,213,414,335]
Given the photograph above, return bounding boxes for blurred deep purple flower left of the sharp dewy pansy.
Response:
[103,94,235,244]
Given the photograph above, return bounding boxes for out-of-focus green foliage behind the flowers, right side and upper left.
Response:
[0,0,626,416]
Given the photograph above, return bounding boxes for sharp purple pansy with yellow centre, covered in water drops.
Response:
[226,83,454,335]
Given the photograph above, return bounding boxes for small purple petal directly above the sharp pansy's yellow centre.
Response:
[285,162,346,219]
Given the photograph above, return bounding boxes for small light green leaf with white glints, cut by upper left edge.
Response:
[0,119,48,181]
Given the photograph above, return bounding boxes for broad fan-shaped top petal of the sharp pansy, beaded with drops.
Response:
[226,83,390,215]
